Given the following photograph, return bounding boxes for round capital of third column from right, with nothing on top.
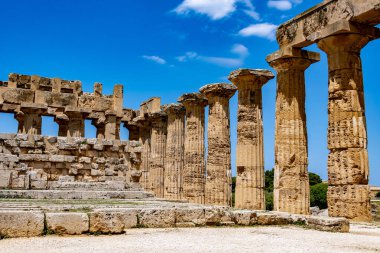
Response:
[228,69,274,89]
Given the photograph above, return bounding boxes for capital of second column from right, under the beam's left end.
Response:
[266,47,320,72]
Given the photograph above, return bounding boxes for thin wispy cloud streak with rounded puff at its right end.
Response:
[176,44,249,67]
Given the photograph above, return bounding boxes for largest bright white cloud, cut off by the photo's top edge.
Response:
[174,0,262,20]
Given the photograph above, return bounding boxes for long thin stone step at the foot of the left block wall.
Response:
[0,189,154,199]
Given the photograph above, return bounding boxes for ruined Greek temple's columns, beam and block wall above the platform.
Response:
[0,0,380,221]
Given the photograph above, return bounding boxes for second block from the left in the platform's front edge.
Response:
[46,213,89,235]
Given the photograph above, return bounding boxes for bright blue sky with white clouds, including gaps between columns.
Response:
[0,0,380,185]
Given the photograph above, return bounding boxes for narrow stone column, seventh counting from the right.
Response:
[149,112,167,198]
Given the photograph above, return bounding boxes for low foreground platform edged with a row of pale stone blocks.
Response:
[0,199,349,238]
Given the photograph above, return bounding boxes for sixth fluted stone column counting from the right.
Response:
[164,104,185,199]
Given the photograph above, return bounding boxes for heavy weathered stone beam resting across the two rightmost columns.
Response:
[277,0,380,48]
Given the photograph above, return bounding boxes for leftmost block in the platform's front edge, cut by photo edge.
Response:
[0,210,45,237]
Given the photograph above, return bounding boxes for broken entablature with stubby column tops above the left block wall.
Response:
[0,74,125,139]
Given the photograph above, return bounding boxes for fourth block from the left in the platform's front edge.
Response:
[138,208,176,228]
